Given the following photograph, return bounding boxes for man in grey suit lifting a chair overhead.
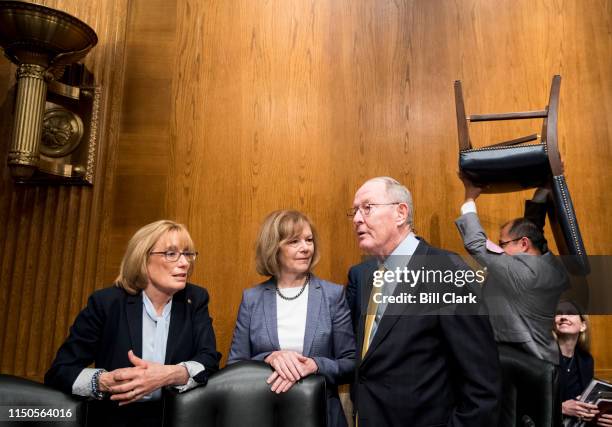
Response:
[456,175,569,365]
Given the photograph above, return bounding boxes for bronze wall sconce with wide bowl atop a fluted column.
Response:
[0,0,99,183]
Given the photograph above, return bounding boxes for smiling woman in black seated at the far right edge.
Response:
[554,301,612,426]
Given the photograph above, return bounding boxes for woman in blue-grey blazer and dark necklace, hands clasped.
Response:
[228,210,355,427]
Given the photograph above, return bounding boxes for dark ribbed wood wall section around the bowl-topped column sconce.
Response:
[0,0,128,380]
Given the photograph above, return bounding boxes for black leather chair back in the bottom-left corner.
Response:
[0,374,87,427]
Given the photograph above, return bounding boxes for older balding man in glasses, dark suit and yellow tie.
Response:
[347,177,500,427]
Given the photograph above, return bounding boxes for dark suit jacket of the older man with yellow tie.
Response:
[347,240,501,427]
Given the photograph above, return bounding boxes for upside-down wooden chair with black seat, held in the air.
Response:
[455,75,590,276]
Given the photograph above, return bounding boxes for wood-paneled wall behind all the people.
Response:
[0,0,612,378]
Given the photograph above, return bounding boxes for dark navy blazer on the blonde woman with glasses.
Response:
[45,284,221,393]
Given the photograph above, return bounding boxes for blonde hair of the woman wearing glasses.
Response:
[115,219,194,295]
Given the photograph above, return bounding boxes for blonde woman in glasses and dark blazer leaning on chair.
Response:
[45,220,221,426]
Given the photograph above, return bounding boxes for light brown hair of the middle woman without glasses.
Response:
[255,210,320,277]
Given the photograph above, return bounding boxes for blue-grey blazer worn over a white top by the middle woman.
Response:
[227,276,355,427]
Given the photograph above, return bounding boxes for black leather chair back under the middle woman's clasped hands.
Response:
[164,361,327,427]
